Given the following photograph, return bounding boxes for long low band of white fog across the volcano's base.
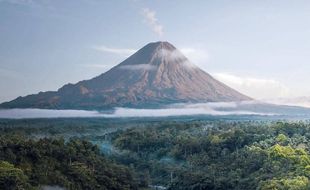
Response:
[0,101,310,119]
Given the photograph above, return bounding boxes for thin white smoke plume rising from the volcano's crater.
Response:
[142,8,164,37]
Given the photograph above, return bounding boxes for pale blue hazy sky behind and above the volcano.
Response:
[0,0,310,102]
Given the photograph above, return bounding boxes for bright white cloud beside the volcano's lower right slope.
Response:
[212,73,291,99]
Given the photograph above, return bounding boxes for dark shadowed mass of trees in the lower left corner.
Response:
[0,135,137,190]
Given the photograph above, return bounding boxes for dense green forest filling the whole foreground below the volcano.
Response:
[0,119,310,190]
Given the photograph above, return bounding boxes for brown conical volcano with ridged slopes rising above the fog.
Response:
[0,42,251,109]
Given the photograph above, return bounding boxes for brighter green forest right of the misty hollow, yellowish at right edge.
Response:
[113,122,310,190]
